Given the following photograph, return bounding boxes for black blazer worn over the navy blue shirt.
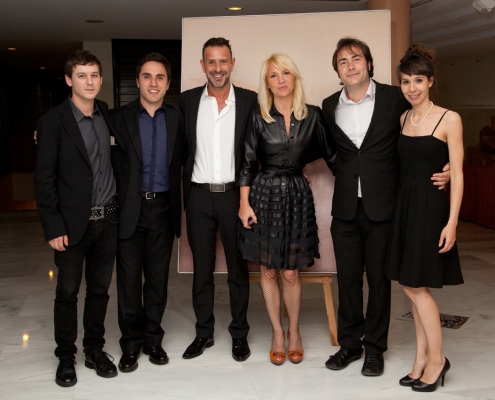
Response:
[110,98,184,239]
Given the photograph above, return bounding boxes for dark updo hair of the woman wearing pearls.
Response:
[395,43,435,81]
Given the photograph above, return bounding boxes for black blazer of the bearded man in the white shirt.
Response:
[179,86,258,208]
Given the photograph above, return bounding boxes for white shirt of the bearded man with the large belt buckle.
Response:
[192,84,235,183]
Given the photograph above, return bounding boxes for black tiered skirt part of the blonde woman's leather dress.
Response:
[238,171,320,270]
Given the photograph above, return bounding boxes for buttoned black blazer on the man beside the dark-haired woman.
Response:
[322,82,410,221]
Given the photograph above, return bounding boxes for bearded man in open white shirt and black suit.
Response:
[179,38,257,361]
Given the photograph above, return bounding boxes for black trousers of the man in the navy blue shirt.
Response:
[117,196,175,352]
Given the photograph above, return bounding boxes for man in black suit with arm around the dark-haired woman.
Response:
[322,38,449,376]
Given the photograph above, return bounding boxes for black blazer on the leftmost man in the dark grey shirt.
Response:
[34,98,112,246]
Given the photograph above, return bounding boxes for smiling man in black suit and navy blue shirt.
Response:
[110,53,184,372]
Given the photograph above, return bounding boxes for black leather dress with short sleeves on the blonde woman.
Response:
[238,105,332,269]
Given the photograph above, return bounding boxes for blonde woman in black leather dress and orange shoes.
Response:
[238,54,330,365]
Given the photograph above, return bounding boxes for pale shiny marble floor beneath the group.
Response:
[0,211,495,400]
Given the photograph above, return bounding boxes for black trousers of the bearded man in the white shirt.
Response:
[186,187,249,338]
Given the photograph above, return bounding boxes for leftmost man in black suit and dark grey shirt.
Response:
[34,50,117,387]
